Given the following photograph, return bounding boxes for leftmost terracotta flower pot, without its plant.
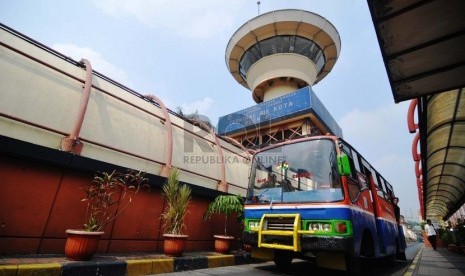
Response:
[65,229,104,261]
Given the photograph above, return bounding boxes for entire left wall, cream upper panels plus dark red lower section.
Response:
[0,25,249,254]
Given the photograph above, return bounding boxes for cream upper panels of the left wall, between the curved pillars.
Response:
[0,25,248,194]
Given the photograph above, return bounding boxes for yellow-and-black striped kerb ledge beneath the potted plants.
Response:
[0,251,252,276]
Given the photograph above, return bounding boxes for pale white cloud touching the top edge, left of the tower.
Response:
[93,0,244,38]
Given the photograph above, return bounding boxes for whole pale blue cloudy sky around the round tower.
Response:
[0,0,419,218]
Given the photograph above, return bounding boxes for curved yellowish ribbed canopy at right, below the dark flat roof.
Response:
[420,89,465,217]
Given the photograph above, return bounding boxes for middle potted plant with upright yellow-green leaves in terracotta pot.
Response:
[161,168,192,257]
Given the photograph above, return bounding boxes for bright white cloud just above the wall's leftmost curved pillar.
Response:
[52,43,131,86]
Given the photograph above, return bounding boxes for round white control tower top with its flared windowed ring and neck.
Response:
[226,9,341,103]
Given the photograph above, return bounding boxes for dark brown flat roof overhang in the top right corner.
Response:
[368,0,465,102]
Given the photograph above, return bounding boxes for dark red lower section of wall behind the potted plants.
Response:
[0,152,241,255]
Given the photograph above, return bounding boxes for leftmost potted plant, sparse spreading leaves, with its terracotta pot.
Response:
[65,170,148,261]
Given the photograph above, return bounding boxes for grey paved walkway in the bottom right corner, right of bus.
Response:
[404,246,465,276]
